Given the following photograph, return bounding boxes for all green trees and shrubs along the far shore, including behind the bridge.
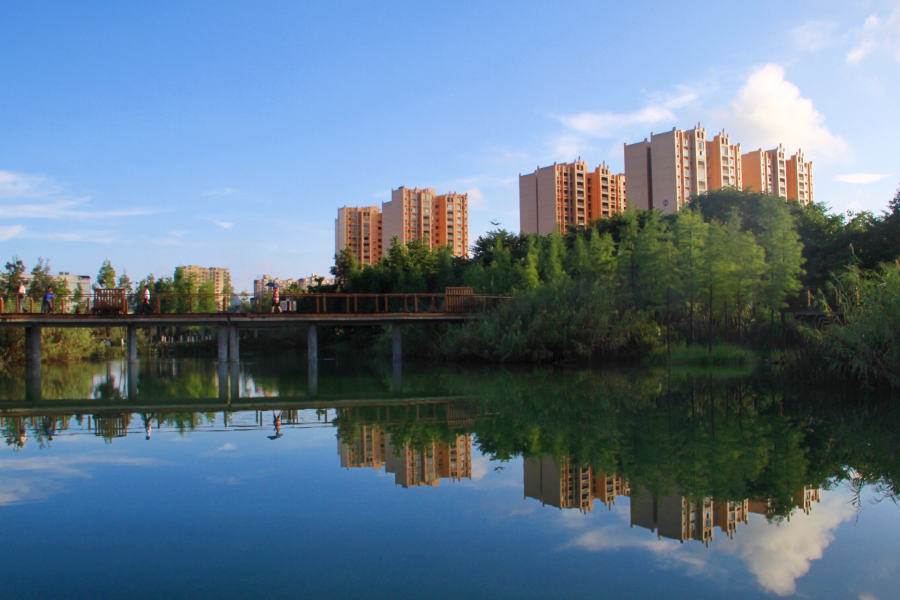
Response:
[0,189,900,388]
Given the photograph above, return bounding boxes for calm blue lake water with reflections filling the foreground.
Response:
[0,357,900,598]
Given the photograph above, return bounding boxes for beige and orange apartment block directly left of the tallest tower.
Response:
[519,159,625,235]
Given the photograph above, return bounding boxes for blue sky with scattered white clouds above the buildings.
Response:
[0,0,900,290]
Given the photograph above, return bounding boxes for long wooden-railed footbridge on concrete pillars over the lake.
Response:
[0,288,507,379]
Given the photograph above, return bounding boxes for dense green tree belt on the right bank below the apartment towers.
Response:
[332,189,900,382]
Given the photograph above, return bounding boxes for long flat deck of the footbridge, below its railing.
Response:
[0,312,477,329]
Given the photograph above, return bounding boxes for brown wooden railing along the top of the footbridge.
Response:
[0,292,509,315]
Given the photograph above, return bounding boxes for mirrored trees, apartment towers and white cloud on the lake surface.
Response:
[0,361,900,594]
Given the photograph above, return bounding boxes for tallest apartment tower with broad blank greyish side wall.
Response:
[625,123,709,214]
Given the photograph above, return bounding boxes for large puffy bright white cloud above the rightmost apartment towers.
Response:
[725,63,848,159]
